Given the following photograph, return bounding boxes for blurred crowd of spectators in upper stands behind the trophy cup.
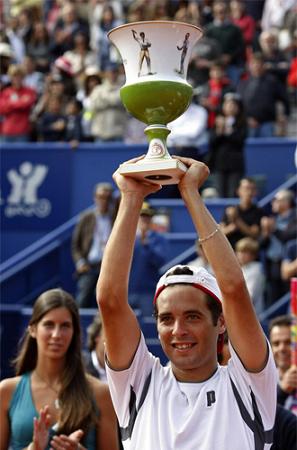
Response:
[0,0,297,156]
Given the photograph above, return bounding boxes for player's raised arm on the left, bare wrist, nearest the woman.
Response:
[97,158,160,369]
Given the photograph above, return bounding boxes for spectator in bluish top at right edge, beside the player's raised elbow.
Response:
[260,189,297,306]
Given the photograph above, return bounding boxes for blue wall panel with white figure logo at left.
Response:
[1,148,71,231]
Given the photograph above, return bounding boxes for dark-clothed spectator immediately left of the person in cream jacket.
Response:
[65,98,83,149]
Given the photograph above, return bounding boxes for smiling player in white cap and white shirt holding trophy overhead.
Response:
[97,157,277,450]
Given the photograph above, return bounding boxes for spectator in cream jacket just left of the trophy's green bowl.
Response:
[89,64,128,142]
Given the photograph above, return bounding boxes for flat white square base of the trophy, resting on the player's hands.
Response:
[119,158,187,185]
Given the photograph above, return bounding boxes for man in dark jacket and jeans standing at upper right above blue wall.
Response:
[238,53,289,137]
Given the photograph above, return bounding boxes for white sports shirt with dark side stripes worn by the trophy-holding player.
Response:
[107,335,277,450]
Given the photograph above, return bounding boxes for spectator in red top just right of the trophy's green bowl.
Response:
[198,62,234,128]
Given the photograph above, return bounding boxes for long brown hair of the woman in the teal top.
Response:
[13,289,97,435]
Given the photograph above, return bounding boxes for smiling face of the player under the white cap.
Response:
[157,284,224,381]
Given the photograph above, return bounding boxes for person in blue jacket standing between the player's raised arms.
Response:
[129,202,169,316]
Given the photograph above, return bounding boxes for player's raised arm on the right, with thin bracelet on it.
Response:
[178,157,268,372]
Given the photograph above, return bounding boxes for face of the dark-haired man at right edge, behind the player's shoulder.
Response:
[270,325,291,370]
